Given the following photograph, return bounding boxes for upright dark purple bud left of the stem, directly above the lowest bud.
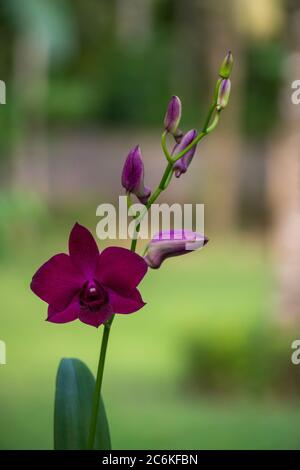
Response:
[122,145,151,204]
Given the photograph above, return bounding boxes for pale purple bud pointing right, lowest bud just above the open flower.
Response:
[144,230,208,269]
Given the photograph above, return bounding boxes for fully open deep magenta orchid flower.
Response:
[31,224,147,327]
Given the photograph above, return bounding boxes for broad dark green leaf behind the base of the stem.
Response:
[54,359,111,450]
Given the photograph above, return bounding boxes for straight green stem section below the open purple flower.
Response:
[87,315,114,450]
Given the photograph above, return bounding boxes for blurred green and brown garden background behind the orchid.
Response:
[0,0,300,449]
